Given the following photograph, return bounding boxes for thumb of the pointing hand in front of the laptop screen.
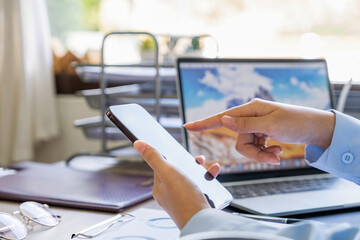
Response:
[221,115,268,134]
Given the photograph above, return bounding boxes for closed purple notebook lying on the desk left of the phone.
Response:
[0,162,152,212]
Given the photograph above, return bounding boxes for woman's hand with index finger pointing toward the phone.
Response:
[184,99,335,164]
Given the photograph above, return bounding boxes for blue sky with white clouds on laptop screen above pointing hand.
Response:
[181,63,331,121]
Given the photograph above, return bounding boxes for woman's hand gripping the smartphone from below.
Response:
[134,141,214,229]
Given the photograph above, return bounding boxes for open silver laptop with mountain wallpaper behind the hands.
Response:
[177,58,360,216]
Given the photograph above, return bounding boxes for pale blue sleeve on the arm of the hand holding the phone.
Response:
[181,209,360,240]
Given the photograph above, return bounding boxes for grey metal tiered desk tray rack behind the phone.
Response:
[70,32,217,160]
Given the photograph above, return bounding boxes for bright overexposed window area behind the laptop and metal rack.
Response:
[46,0,360,81]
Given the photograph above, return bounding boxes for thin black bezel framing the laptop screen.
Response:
[176,58,334,182]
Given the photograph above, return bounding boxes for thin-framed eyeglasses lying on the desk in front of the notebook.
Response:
[0,202,60,240]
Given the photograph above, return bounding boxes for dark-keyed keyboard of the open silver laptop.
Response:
[226,177,338,199]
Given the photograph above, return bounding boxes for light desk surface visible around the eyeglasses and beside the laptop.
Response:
[0,199,360,240]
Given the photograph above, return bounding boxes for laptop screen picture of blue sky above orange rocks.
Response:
[180,62,331,170]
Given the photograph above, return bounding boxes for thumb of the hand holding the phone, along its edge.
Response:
[134,140,170,176]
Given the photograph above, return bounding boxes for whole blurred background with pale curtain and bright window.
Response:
[0,0,360,166]
